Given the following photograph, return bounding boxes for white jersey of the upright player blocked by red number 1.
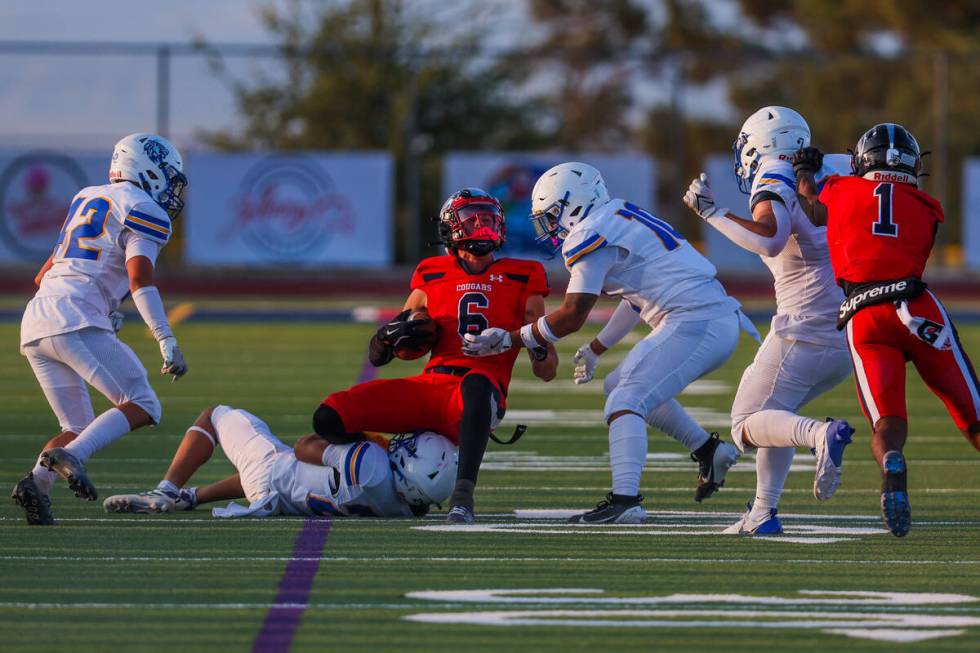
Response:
[749,154,850,346]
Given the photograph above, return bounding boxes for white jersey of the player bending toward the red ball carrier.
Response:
[562,199,740,327]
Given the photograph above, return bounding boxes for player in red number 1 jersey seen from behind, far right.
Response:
[793,123,980,537]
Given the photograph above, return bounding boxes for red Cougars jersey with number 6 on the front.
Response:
[412,254,549,393]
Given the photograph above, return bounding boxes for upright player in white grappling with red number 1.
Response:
[684,106,854,535]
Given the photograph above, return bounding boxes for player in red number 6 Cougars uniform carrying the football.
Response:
[313,188,558,524]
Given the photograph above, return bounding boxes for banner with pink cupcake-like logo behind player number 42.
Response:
[0,150,109,267]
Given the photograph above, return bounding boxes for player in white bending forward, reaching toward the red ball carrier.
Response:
[464,163,758,523]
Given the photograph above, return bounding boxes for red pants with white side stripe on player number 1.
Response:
[846,290,980,429]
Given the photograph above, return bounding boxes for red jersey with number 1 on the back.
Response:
[820,177,943,283]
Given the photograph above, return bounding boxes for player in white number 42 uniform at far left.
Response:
[12,134,187,524]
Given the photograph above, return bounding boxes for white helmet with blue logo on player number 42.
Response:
[109,133,187,218]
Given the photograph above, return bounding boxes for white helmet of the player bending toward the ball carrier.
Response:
[531,161,609,256]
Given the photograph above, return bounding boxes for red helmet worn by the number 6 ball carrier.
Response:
[439,188,507,256]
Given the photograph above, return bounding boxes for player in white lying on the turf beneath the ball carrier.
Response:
[103,406,456,517]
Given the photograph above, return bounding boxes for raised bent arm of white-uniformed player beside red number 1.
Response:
[684,172,790,256]
